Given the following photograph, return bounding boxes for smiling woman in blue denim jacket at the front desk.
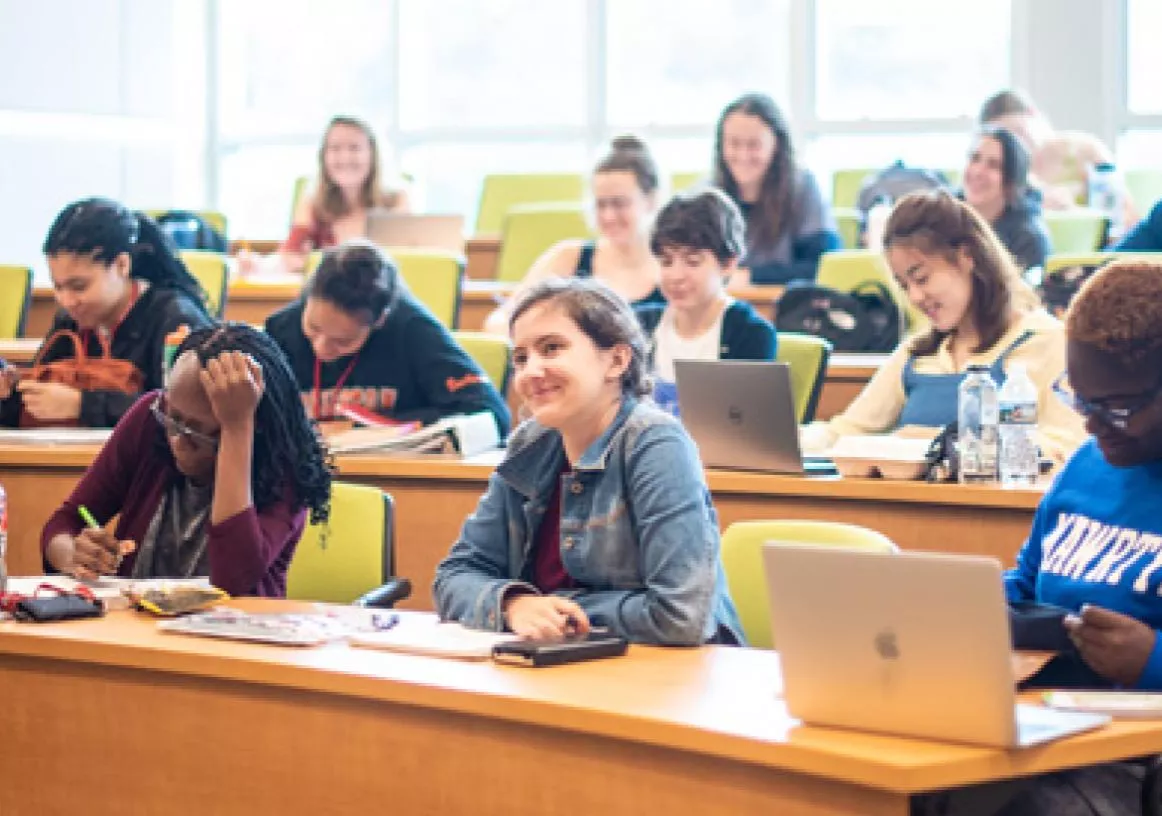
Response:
[435,278,741,645]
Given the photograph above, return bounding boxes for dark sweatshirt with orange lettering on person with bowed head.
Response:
[266,294,509,437]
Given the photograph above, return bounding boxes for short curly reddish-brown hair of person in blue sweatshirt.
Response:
[1066,258,1162,366]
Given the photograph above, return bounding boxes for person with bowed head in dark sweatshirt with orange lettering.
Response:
[266,241,509,437]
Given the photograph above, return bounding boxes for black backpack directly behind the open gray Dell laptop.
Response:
[775,280,904,351]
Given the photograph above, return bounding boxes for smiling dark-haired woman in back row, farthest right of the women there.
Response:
[961,127,1049,270]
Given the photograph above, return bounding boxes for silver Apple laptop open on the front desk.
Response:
[762,544,1109,747]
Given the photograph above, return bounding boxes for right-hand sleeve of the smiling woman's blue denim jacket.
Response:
[560,424,718,645]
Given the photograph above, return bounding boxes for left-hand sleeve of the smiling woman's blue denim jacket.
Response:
[433,473,537,631]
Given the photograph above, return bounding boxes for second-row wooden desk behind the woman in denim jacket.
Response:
[0,445,1042,609]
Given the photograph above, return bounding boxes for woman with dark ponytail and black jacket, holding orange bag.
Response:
[0,198,211,428]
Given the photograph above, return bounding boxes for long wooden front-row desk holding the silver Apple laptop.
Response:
[0,600,1162,816]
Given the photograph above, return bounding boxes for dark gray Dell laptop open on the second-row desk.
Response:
[674,360,838,477]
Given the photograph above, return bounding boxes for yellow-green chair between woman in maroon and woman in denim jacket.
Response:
[287,481,395,603]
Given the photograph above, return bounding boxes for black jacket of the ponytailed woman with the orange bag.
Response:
[0,286,211,428]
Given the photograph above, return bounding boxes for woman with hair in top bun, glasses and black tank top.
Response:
[485,136,665,337]
